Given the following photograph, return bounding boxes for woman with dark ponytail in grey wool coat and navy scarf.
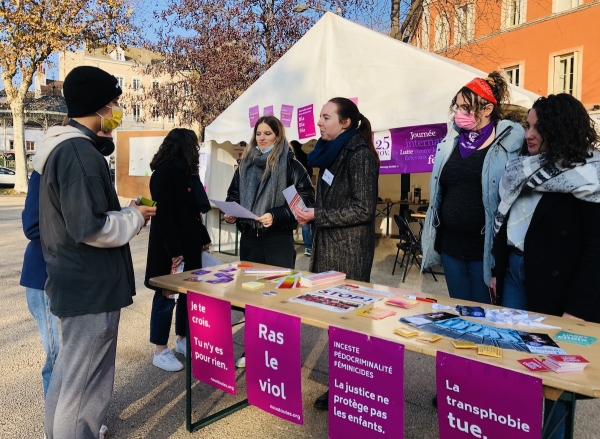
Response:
[296,97,379,410]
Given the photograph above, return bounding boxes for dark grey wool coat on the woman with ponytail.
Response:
[310,135,379,282]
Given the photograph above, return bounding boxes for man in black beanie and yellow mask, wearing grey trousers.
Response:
[33,66,156,439]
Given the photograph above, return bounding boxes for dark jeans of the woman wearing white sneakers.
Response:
[150,291,188,346]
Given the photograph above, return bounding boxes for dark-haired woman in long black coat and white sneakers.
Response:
[144,128,211,372]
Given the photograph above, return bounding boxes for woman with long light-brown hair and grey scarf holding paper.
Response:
[225,116,315,268]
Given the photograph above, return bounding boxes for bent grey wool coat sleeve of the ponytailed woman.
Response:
[315,148,379,228]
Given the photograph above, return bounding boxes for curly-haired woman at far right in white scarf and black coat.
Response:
[491,93,600,439]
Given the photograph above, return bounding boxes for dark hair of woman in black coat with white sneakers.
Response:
[150,128,200,175]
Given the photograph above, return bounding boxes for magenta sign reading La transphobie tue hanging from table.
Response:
[436,352,542,439]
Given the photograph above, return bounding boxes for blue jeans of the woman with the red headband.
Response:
[441,253,490,303]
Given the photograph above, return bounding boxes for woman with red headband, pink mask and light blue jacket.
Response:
[423,72,525,303]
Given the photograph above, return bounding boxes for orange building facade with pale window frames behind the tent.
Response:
[404,0,600,114]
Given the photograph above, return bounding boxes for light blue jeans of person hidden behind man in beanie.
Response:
[25,288,59,399]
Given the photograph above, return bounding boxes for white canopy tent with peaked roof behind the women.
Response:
[205,13,537,248]
